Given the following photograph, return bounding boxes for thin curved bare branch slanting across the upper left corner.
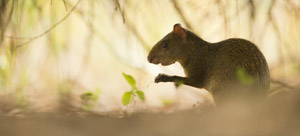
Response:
[8,0,81,48]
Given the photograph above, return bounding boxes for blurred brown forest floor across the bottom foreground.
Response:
[0,85,300,136]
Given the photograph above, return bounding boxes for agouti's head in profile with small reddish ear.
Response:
[148,24,187,66]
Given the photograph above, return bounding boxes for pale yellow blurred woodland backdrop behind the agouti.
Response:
[0,0,300,114]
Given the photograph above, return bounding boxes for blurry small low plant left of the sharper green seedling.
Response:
[80,88,100,110]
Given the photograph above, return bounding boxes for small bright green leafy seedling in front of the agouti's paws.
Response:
[122,73,145,106]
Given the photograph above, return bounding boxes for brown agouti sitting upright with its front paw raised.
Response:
[148,24,270,105]
